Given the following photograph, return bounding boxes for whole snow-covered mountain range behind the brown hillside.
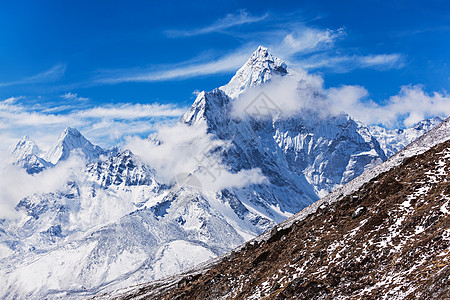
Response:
[0,47,442,298]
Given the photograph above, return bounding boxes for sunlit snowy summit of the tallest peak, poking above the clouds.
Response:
[220,46,288,98]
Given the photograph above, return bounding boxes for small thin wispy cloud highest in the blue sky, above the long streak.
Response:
[165,10,268,37]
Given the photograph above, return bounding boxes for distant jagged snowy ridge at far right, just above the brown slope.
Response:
[369,117,444,157]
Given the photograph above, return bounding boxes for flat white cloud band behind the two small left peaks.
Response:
[0,98,185,150]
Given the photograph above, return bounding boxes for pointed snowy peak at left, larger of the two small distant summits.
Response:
[44,127,104,164]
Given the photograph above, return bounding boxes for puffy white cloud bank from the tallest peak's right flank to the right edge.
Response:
[233,72,450,128]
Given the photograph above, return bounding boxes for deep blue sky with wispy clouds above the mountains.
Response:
[0,0,450,148]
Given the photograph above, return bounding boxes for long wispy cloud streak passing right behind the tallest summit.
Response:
[93,24,344,84]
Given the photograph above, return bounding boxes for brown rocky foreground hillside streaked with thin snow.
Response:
[117,119,450,299]
